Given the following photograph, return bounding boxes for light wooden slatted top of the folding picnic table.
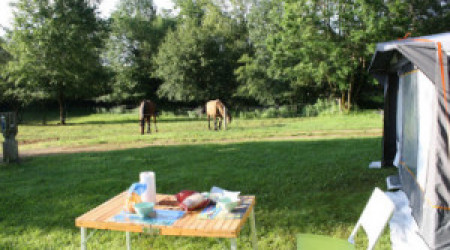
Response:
[75,192,256,238]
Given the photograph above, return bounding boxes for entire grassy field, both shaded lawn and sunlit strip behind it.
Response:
[0,113,394,249]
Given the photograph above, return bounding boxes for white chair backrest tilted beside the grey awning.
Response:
[348,188,395,250]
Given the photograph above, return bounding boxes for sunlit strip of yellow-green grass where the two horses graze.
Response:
[5,112,382,151]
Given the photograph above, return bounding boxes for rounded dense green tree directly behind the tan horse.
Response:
[154,0,247,102]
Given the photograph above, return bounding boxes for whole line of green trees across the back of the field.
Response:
[0,0,450,124]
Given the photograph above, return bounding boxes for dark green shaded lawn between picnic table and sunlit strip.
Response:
[0,138,394,246]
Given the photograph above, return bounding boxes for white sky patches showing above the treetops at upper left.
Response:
[0,0,173,35]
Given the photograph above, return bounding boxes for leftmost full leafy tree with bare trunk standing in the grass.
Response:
[7,0,104,124]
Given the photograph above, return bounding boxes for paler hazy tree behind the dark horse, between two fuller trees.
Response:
[105,0,174,102]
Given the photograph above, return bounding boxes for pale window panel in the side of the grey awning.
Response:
[396,70,437,187]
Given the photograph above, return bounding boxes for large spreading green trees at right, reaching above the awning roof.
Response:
[235,0,450,108]
